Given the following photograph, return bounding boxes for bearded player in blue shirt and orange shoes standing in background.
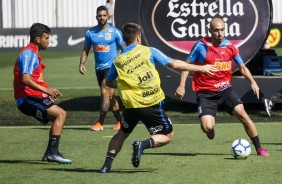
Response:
[79,6,125,131]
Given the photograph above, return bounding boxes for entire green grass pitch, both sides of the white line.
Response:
[0,49,282,184]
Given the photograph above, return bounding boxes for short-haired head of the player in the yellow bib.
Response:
[122,23,142,45]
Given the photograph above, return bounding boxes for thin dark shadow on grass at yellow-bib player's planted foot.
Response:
[46,168,156,174]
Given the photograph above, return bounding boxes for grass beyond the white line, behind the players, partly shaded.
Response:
[0,49,282,125]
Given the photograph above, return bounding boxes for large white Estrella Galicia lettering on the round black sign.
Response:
[167,0,245,38]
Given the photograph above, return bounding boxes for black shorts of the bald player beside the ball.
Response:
[197,87,242,117]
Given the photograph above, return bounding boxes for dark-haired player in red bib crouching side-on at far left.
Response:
[14,23,72,164]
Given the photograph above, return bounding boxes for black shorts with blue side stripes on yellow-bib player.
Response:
[121,101,173,135]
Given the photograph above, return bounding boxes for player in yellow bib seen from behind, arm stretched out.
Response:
[100,23,216,173]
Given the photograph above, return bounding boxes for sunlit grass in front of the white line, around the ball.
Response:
[0,123,282,184]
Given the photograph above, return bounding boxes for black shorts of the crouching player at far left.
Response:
[18,97,54,125]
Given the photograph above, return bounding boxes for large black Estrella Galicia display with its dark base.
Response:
[115,0,276,103]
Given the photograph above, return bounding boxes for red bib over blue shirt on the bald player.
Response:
[187,38,243,92]
